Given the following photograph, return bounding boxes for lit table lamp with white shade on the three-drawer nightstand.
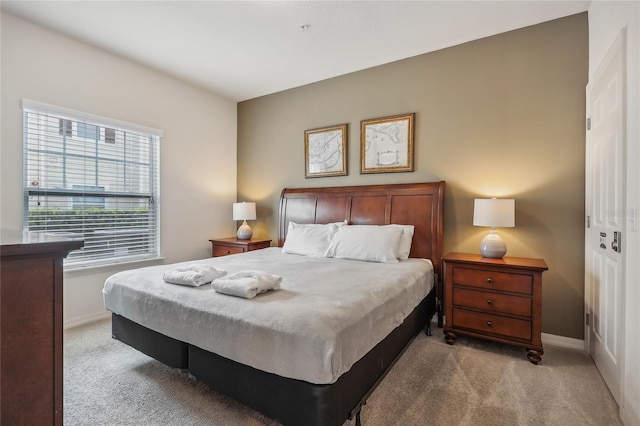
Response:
[473,198,515,259]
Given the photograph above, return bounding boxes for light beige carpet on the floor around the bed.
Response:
[63,320,622,426]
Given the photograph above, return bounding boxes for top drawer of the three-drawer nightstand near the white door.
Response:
[452,267,533,294]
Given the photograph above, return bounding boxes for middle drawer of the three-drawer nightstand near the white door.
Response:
[453,287,531,317]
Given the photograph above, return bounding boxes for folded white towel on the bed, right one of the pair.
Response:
[211,270,282,299]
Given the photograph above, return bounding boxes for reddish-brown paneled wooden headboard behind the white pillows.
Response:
[278,181,445,274]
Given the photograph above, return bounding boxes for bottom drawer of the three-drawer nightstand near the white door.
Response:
[452,308,531,341]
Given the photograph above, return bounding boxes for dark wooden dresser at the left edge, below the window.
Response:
[0,229,84,425]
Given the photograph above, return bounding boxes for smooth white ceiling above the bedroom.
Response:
[1,0,590,101]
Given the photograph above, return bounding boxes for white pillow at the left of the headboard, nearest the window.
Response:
[282,222,338,257]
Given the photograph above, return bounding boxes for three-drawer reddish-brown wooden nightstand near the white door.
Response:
[442,253,548,364]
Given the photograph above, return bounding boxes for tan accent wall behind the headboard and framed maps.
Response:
[238,13,588,339]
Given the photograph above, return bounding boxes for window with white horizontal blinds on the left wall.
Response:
[23,100,162,267]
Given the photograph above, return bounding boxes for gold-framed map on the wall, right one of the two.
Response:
[360,113,415,173]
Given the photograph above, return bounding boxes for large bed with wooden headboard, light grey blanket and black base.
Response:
[104,182,445,425]
